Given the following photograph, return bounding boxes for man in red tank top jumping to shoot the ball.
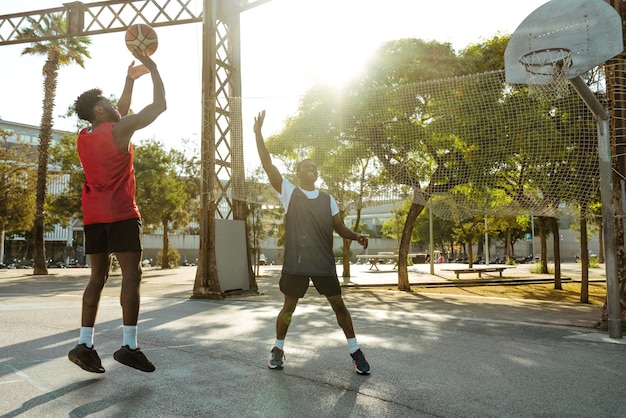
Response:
[68,50,167,373]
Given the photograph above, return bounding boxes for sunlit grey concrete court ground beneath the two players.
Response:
[0,266,626,417]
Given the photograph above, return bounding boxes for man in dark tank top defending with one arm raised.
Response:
[254,111,370,374]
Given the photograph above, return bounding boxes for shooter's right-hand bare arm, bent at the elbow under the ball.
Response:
[113,49,167,150]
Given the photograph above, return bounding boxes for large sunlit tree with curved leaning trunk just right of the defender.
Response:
[270,39,502,290]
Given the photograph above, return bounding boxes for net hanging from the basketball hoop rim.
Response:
[519,48,572,99]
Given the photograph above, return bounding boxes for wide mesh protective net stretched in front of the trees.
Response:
[232,71,606,220]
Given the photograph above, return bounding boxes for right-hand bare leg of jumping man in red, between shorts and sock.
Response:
[115,251,141,325]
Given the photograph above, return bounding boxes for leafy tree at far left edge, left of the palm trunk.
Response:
[0,129,35,262]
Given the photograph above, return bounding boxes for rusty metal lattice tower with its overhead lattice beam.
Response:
[0,0,271,297]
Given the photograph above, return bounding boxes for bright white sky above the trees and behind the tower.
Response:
[0,0,547,159]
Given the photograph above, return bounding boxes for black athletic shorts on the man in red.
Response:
[84,219,143,254]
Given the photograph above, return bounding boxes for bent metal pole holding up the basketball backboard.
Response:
[570,77,622,338]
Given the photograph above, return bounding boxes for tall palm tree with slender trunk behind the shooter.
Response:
[18,14,91,274]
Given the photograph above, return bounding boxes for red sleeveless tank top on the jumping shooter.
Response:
[77,122,141,225]
